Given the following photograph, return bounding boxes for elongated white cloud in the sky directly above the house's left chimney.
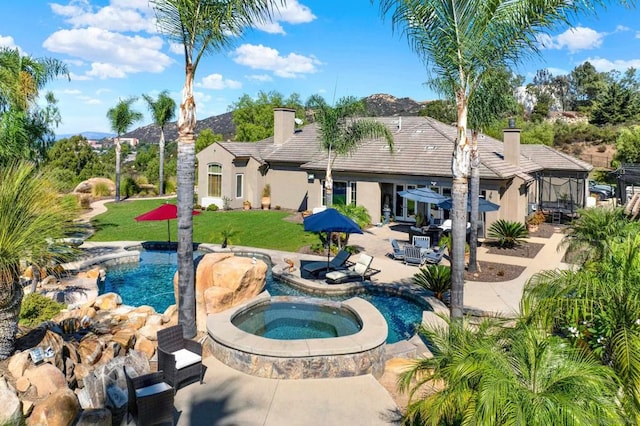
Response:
[231,44,321,78]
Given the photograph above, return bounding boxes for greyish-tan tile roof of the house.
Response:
[214,117,592,180]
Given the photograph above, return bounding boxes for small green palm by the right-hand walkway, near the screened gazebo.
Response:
[560,207,640,264]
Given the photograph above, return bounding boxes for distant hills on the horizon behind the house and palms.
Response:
[123,94,427,143]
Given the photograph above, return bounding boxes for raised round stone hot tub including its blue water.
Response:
[207,294,387,379]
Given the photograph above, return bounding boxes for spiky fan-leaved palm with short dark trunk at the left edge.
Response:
[0,162,77,359]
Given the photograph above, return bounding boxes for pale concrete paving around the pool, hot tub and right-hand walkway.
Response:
[77,200,568,426]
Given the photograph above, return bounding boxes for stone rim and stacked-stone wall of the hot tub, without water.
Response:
[205,293,388,379]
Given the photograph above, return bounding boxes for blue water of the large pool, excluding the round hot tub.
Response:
[99,250,428,343]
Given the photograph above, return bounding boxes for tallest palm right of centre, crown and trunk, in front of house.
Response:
[372,0,580,318]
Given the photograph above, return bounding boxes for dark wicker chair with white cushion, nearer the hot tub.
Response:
[158,325,204,391]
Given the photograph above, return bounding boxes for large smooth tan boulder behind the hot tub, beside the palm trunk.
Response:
[178,253,267,331]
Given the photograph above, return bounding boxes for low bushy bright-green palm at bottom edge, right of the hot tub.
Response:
[399,319,622,426]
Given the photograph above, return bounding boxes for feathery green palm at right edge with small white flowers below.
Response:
[520,234,640,423]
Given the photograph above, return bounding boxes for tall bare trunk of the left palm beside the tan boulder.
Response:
[177,64,197,338]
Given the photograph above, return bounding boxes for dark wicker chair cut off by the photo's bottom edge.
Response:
[124,367,175,426]
